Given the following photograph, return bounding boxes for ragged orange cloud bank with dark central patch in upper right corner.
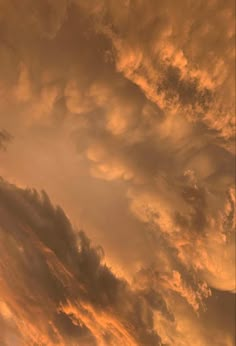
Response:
[77,1,235,150]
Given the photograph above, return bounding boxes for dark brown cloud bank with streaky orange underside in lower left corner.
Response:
[0,180,161,345]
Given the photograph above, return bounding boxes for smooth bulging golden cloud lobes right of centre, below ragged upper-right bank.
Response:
[68,74,235,296]
